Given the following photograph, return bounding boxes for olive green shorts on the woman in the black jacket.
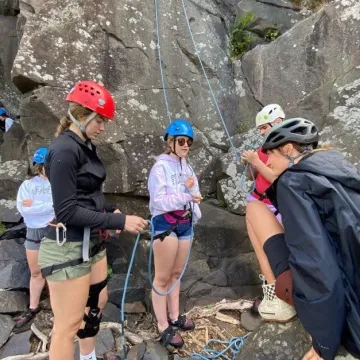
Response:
[39,237,106,281]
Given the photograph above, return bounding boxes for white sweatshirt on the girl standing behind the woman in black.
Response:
[16,176,55,229]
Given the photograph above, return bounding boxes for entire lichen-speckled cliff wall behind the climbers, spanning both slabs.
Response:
[0,0,360,214]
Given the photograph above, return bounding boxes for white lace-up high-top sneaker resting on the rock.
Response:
[258,274,296,322]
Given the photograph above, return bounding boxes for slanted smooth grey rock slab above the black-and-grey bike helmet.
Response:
[242,0,360,163]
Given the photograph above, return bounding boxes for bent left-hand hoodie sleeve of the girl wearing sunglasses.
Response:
[148,164,192,212]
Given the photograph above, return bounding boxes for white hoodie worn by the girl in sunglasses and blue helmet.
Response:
[148,154,201,223]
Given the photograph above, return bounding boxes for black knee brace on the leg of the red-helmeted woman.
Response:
[77,279,107,339]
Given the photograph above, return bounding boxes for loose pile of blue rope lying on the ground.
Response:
[190,335,248,360]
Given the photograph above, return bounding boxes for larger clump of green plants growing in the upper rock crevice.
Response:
[230,13,255,61]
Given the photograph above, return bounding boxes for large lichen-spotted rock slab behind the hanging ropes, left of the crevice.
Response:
[12,0,238,195]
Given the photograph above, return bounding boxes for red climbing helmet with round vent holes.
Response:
[66,80,115,120]
